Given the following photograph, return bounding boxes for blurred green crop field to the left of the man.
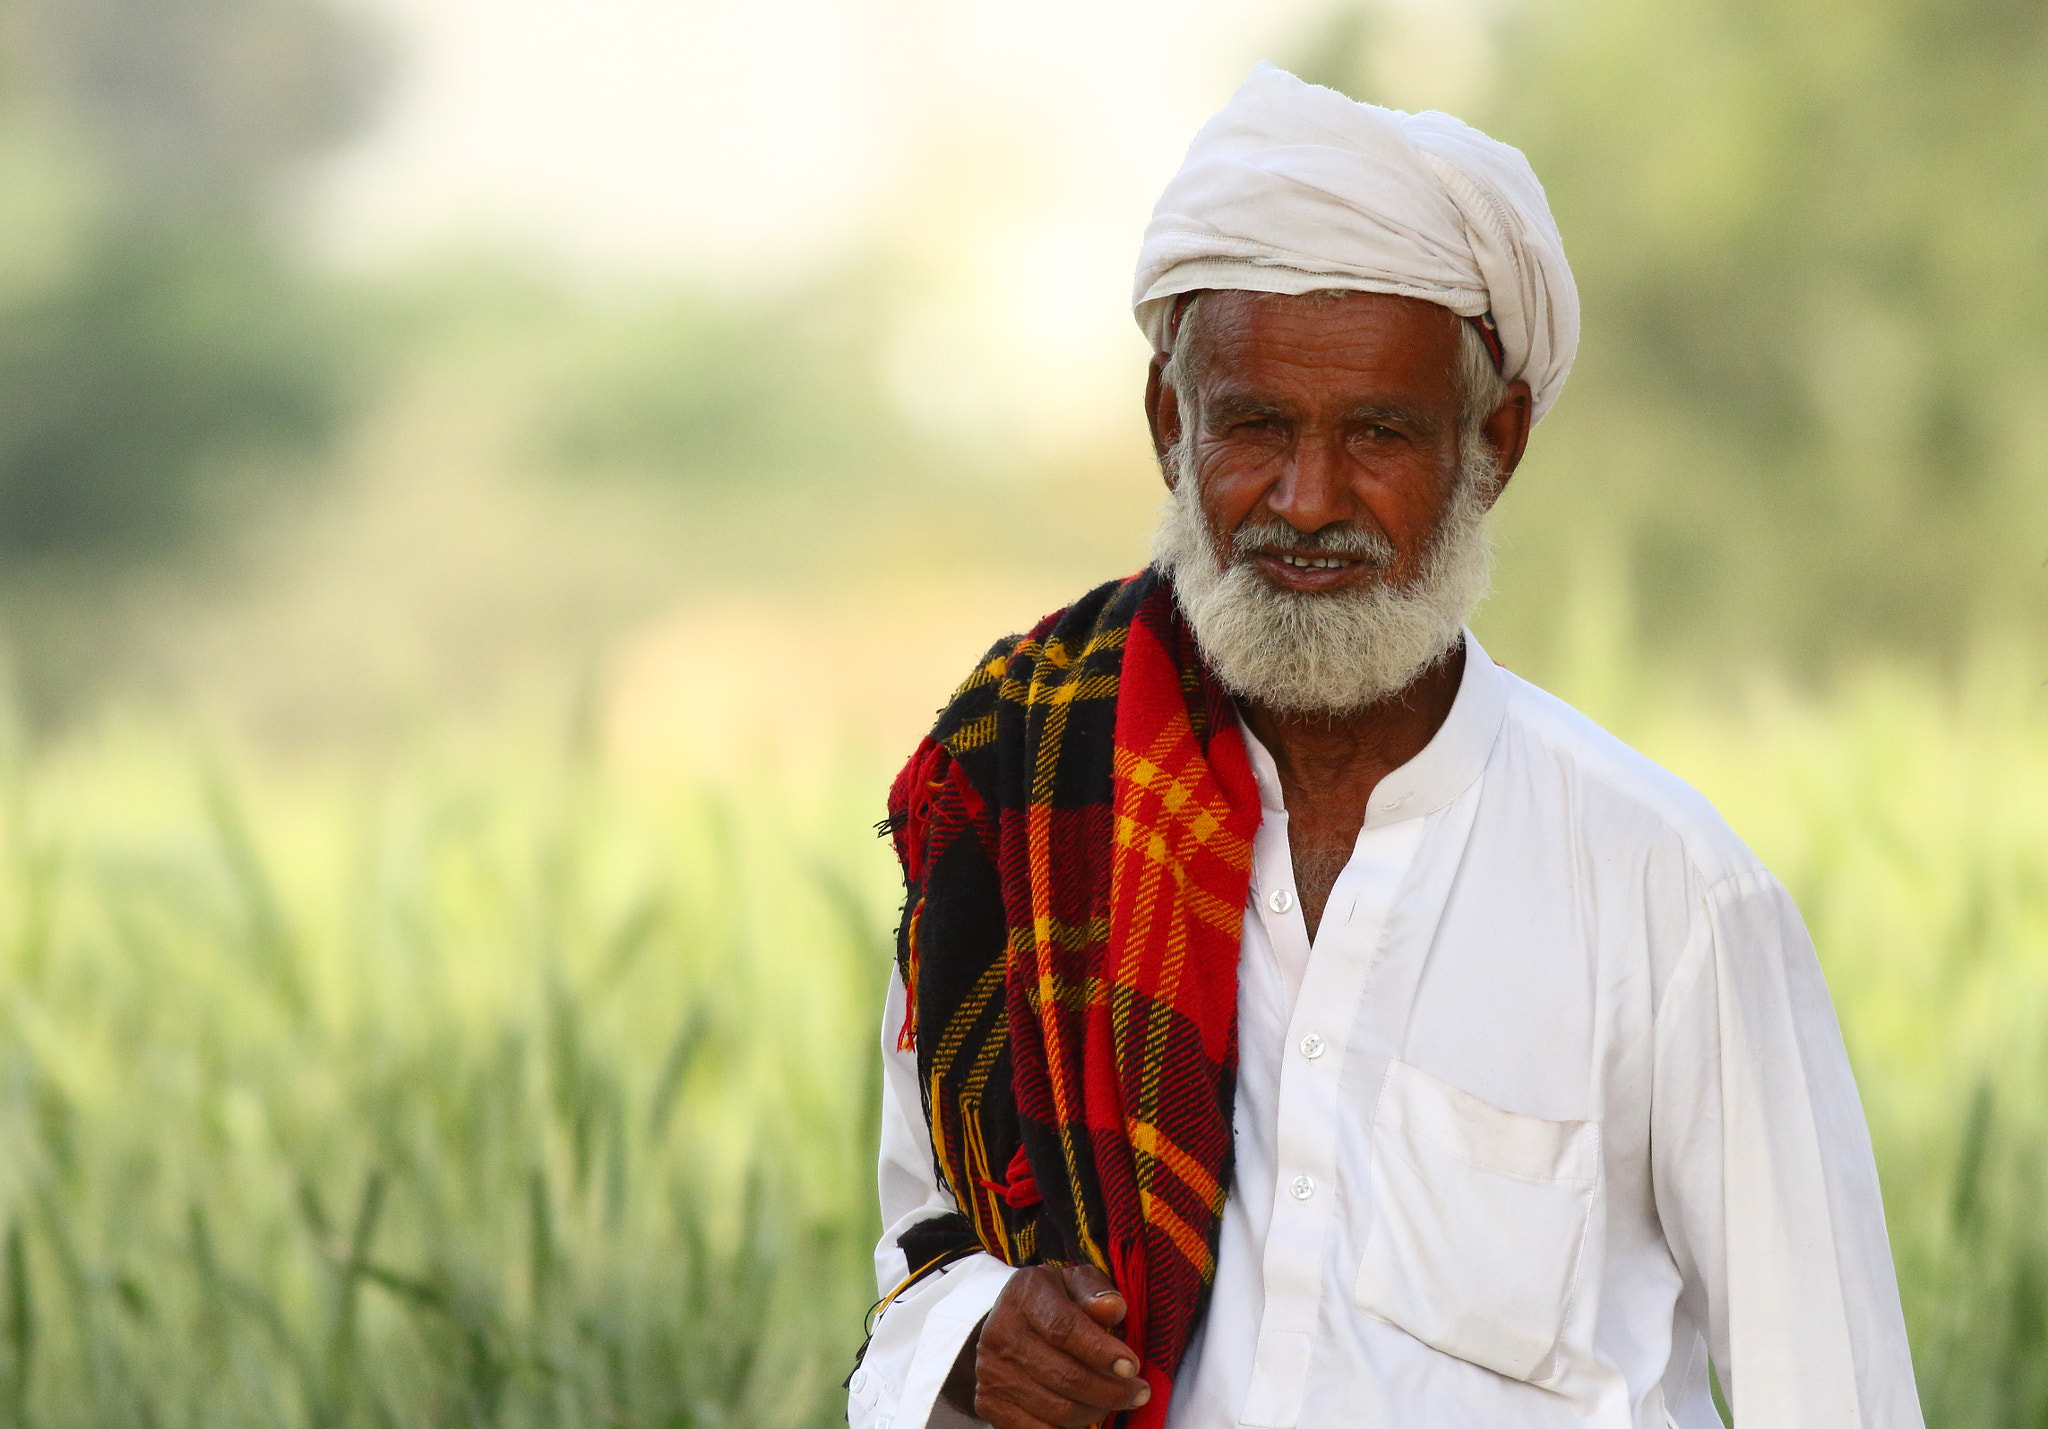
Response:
[0,731,891,1429]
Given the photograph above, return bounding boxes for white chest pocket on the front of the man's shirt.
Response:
[1354,1060,1599,1384]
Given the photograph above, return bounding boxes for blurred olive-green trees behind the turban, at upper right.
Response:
[1305,0,2048,672]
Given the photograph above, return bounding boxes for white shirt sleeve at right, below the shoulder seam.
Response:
[1651,870,1921,1429]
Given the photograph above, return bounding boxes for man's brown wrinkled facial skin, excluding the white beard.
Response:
[1161,293,1490,594]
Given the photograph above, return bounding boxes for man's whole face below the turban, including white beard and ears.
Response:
[1147,293,1528,715]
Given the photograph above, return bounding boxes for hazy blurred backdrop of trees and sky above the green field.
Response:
[0,0,2048,745]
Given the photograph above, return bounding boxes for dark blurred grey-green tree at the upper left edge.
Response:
[0,0,377,719]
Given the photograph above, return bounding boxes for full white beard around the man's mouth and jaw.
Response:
[1153,438,1495,715]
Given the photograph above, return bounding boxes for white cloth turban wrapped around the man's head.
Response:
[1130,63,1579,418]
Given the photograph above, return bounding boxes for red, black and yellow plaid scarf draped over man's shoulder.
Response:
[889,571,1260,1429]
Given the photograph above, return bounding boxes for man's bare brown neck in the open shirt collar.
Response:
[1243,643,1464,938]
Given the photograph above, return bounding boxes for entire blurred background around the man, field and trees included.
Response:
[0,0,2048,1429]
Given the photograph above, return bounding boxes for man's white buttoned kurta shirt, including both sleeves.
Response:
[850,635,1921,1429]
